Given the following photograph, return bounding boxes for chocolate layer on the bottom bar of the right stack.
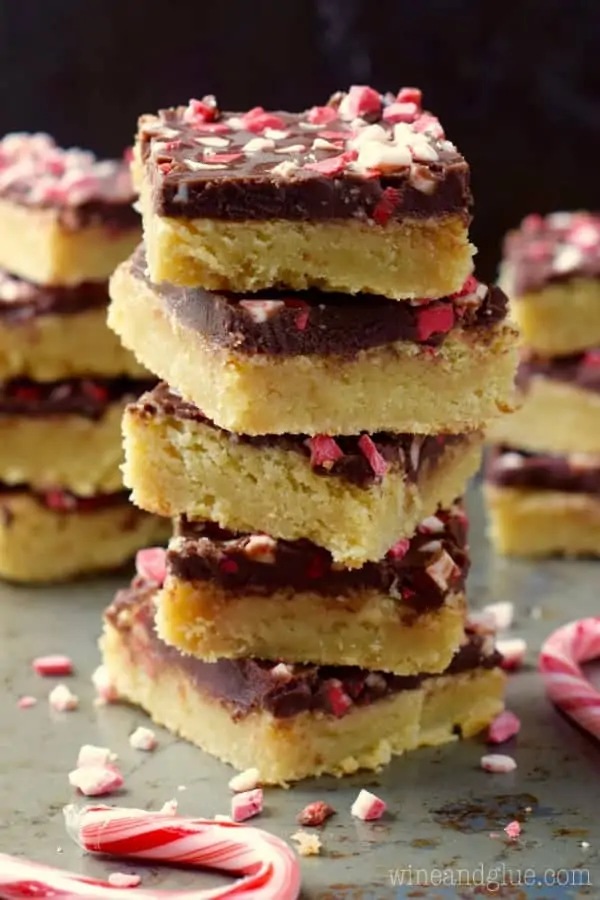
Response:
[485,447,600,494]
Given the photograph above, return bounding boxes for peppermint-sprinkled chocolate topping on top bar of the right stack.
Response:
[503,212,600,297]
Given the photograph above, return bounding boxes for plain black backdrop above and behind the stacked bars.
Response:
[0,0,600,277]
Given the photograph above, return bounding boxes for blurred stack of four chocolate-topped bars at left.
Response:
[0,134,164,582]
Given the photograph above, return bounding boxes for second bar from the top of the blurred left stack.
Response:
[0,269,148,381]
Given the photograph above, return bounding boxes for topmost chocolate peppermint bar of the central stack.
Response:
[134,86,473,299]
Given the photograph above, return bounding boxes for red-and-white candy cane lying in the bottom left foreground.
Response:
[0,806,300,900]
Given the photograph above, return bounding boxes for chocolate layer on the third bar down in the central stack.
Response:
[130,382,473,489]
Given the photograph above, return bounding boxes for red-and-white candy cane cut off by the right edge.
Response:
[539,616,600,738]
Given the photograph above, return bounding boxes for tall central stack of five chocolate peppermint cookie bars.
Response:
[102,87,515,783]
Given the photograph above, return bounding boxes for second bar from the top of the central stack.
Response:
[109,250,516,435]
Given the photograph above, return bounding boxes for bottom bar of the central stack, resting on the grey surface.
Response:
[101,579,505,784]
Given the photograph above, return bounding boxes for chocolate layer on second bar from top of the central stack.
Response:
[130,247,508,358]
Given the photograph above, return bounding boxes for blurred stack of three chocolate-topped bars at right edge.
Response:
[486,212,600,556]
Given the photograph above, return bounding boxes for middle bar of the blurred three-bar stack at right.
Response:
[488,350,600,454]
